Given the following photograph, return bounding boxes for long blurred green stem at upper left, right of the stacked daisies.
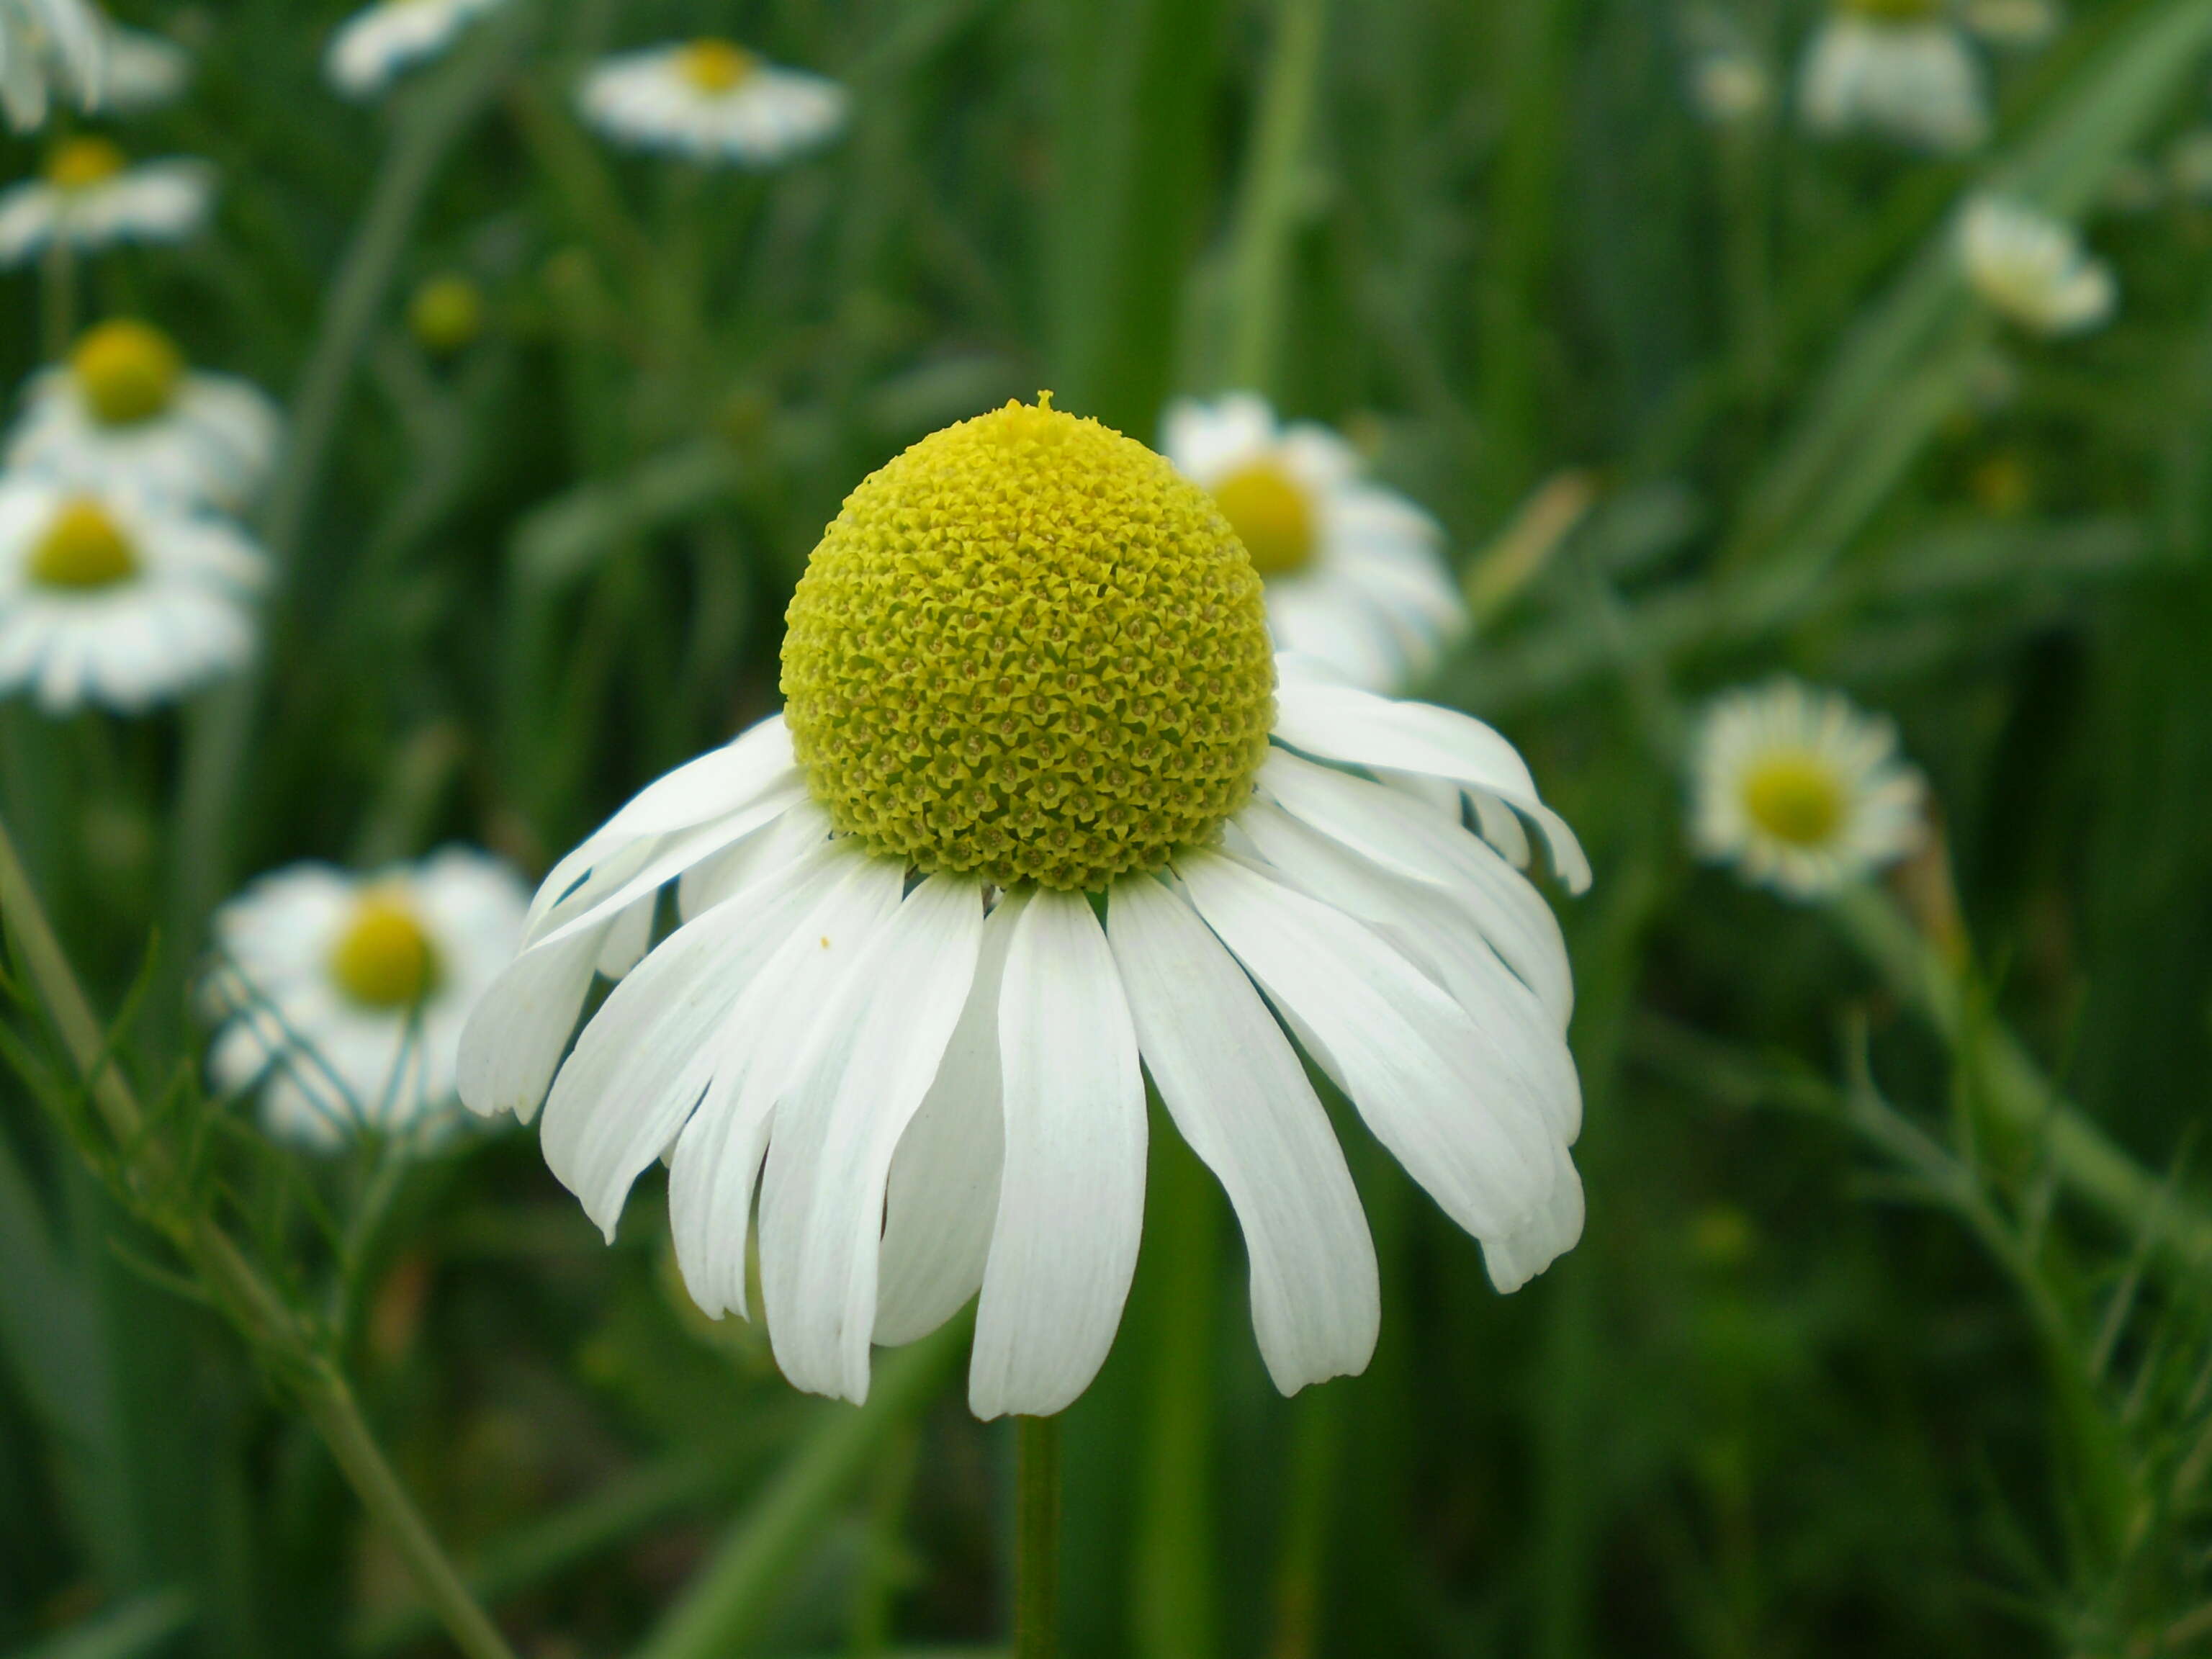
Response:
[168,6,531,973]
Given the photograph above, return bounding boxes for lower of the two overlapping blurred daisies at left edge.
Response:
[0,473,266,714]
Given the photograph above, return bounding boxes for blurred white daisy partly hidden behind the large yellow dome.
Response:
[1166,392,1467,690]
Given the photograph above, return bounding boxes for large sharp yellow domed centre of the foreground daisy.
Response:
[783,398,1274,889]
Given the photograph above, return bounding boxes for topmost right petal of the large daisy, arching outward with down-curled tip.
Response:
[1274,675,1591,894]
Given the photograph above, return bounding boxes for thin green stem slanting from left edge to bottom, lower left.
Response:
[0,821,513,1659]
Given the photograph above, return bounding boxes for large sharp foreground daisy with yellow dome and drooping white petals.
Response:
[460,403,1588,1418]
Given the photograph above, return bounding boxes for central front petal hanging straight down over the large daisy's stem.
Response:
[969,891,1146,1420]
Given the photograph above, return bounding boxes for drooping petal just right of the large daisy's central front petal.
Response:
[1106,878,1382,1393]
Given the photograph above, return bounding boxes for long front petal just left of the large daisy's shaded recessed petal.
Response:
[761,873,982,1401]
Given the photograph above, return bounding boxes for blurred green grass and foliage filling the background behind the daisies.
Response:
[0,0,2212,1659]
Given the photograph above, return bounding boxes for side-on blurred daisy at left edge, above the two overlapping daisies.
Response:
[0,137,215,266]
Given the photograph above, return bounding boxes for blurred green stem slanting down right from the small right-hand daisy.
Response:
[1834,887,2212,1269]
